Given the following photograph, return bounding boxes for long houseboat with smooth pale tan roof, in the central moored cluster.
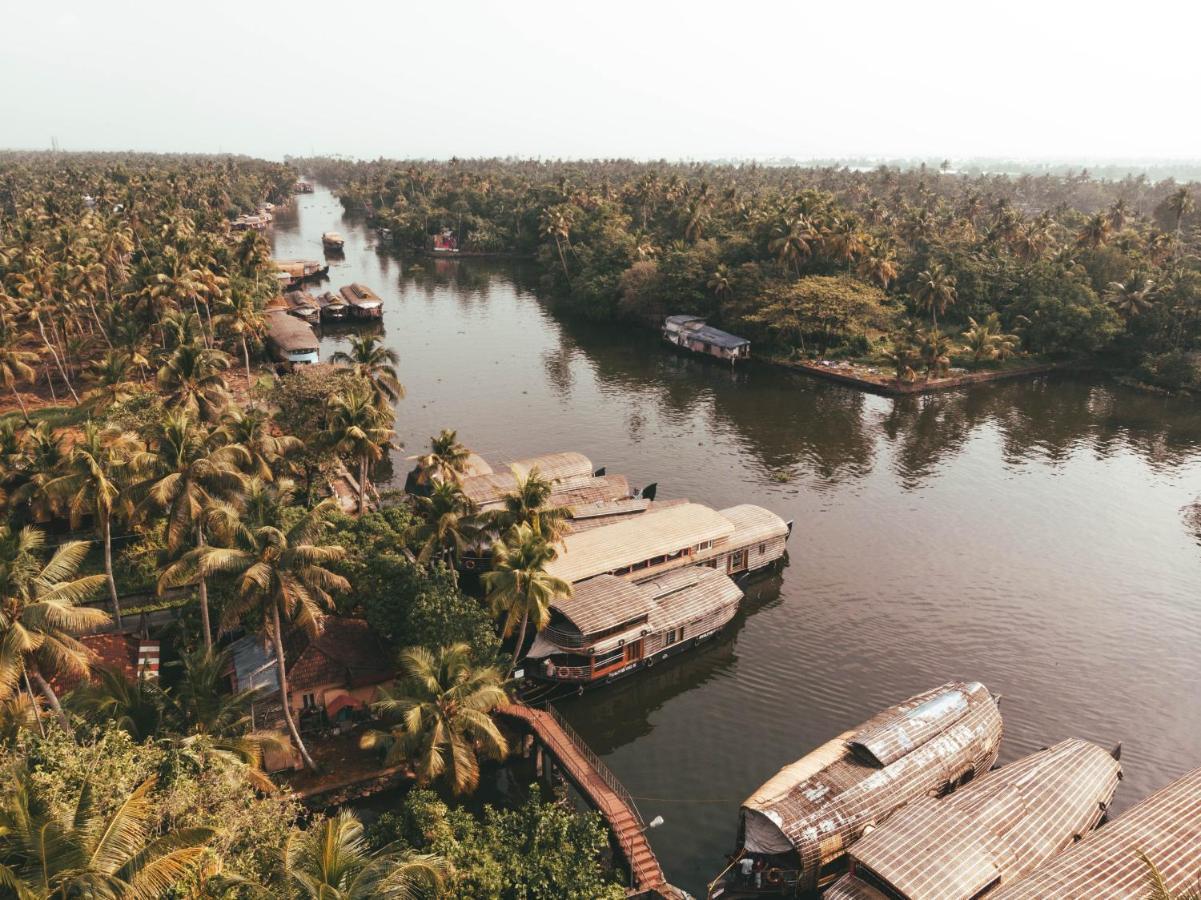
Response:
[546,502,791,584]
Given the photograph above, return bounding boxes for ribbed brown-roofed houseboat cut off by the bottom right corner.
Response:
[988,769,1201,900]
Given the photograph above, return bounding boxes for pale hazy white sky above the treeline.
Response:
[9,0,1201,161]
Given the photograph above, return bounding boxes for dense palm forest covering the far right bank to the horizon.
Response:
[292,159,1201,386]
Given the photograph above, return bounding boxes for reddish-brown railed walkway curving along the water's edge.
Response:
[496,704,687,898]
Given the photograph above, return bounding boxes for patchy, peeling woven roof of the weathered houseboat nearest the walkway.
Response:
[742,683,1002,888]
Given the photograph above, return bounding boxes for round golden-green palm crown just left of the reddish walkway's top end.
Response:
[360,644,509,794]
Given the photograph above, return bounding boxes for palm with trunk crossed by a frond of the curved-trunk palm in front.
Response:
[137,411,250,650]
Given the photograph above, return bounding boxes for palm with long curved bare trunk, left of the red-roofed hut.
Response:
[161,478,349,769]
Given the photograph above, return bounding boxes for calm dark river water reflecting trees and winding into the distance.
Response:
[274,191,1201,894]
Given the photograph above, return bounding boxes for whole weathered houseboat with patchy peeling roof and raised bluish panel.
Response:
[709,681,1002,900]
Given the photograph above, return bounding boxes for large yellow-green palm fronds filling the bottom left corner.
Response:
[0,770,214,900]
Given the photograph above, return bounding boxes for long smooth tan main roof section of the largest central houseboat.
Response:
[546,503,734,582]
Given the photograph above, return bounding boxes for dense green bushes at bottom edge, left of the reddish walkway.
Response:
[379,788,625,900]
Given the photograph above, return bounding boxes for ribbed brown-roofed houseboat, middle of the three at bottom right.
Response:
[823,739,1122,900]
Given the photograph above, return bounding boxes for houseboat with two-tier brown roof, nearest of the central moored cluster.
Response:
[526,566,742,687]
